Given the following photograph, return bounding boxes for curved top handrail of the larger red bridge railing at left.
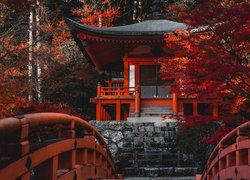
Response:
[0,112,118,178]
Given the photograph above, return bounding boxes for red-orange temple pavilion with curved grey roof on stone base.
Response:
[68,15,218,121]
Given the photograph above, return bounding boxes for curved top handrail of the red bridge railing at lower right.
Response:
[201,121,250,180]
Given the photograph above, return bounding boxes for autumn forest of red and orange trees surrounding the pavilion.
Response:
[0,0,250,168]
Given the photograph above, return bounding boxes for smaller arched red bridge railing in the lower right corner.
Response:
[197,122,250,180]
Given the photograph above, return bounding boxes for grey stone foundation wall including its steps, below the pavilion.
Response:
[90,121,196,177]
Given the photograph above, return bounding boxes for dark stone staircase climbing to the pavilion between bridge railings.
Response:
[118,123,196,177]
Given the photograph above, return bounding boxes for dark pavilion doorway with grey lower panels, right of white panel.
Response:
[140,65,169,98]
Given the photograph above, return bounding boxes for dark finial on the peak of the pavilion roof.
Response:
[148,0,165,20]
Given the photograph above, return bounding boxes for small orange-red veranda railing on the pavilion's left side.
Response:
[100,87,135,97]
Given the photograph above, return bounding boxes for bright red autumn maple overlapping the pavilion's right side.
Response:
[162,0,250,143]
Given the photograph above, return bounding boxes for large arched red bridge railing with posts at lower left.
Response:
[0,113,119,180]
